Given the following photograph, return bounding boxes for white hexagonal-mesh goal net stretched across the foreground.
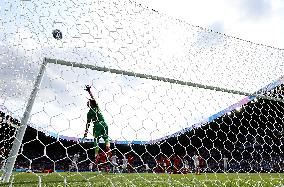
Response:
[0,0,284,186]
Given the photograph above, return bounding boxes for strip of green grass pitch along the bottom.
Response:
[0,172,284,187]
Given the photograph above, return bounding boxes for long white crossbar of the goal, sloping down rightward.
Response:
[46,58,284,103]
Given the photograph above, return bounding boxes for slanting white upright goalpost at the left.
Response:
[2,58,47,182]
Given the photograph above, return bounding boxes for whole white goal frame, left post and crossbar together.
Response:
[2,58,284,182]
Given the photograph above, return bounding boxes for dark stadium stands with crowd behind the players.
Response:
[0,97,284,173]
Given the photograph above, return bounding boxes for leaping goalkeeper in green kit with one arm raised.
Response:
[84,85,110,156]
